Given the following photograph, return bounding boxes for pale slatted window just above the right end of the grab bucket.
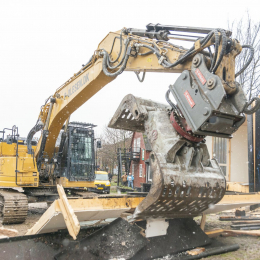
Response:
[213,137,228,176]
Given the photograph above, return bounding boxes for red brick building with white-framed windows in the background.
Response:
[130,132,152,190]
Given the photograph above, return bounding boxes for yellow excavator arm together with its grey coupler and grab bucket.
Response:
[27,24,260,218]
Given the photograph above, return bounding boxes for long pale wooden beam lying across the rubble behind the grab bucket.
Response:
[26,193,260,239]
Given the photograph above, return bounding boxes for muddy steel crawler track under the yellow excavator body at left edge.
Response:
[0,190,28,224]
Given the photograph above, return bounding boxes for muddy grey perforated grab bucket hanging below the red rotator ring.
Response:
[109,95,226,219]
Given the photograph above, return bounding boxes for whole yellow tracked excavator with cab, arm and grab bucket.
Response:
[0,24,260,223]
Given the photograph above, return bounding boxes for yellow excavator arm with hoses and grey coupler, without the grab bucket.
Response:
[28,24,256,158]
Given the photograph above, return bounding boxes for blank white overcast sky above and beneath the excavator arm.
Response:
[0,0,260,137]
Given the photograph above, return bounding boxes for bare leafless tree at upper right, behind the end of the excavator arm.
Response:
[229,13,260,100]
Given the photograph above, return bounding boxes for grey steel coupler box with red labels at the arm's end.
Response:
[168,54,248,138]
